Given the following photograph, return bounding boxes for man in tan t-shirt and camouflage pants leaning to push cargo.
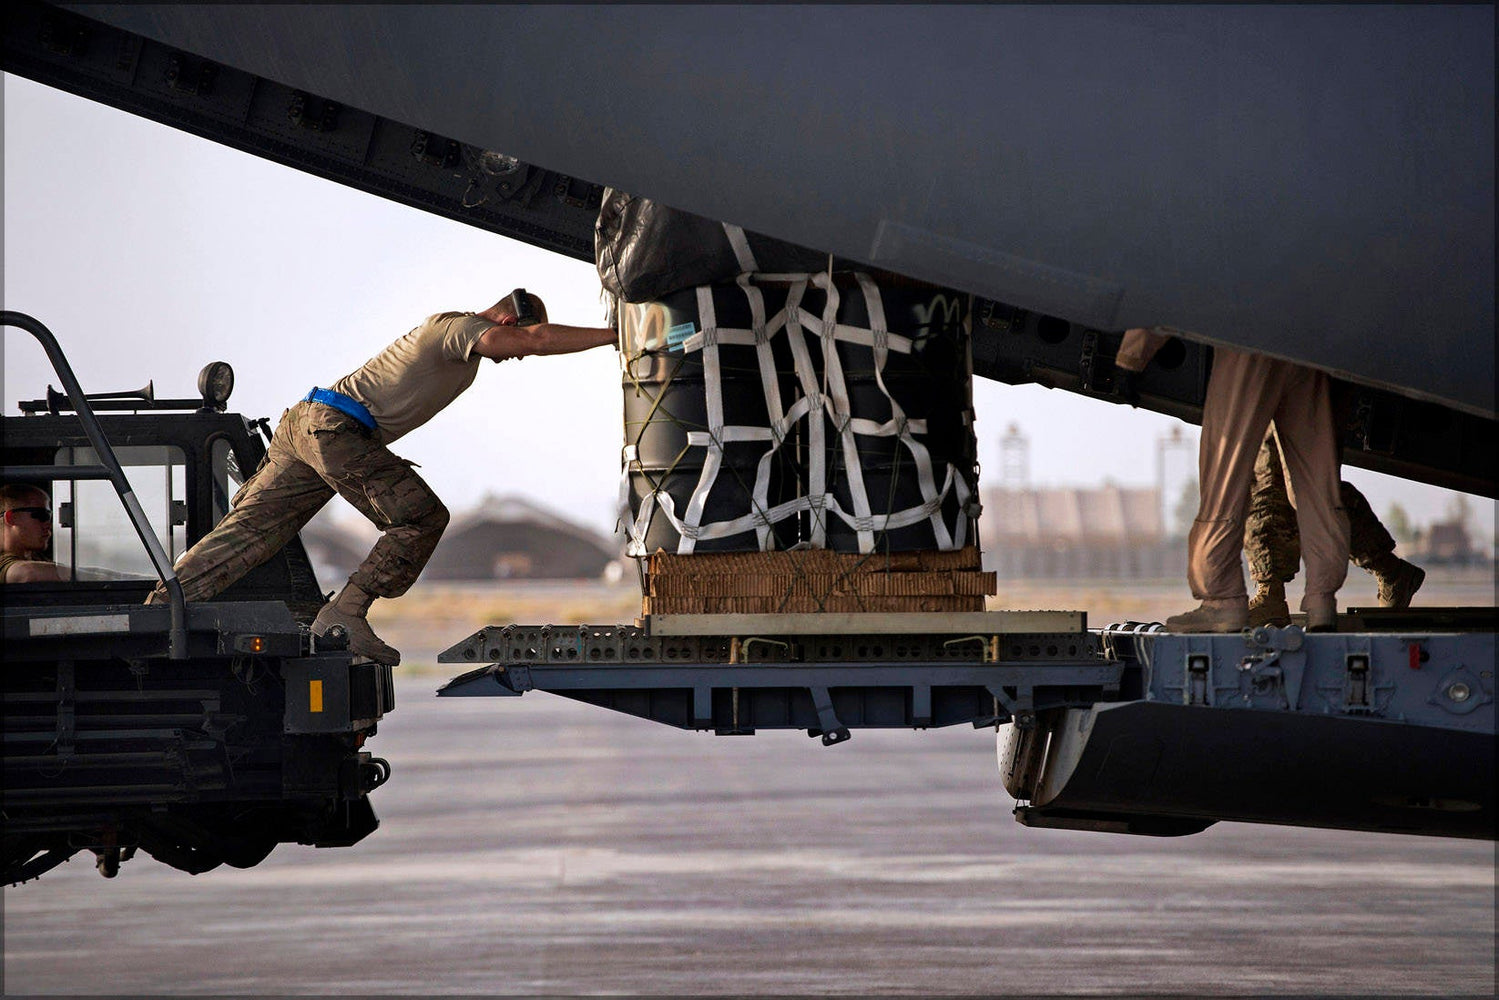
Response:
[147,289,615,666]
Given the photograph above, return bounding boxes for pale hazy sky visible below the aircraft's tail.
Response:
[0,75,1495,548]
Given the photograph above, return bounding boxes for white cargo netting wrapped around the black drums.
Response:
[619,273,977,556]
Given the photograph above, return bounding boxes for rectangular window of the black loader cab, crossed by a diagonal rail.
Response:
[51,445,187,580]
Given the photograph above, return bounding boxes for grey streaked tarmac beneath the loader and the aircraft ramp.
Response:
[3,675,1495,996]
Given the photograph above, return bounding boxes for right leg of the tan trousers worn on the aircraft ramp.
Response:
[1274,364,1349,610]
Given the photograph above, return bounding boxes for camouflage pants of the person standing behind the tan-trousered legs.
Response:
[1244,435,1396,583]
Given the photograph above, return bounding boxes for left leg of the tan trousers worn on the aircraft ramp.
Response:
[1187,348,1289,601]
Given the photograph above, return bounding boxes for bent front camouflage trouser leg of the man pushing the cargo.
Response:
[277,403,448,597]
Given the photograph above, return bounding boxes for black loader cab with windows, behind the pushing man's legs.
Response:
[0,367,322,621]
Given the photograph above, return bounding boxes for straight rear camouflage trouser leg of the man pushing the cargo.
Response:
[151,420,333,601]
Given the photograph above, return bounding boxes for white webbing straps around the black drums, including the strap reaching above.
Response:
[621,269,976,556]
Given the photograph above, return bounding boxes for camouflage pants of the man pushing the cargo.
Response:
[151,402,448,601]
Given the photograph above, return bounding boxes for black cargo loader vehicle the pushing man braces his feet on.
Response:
[0,312,394,885]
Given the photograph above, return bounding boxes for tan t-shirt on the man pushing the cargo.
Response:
[331,312,495,444]
